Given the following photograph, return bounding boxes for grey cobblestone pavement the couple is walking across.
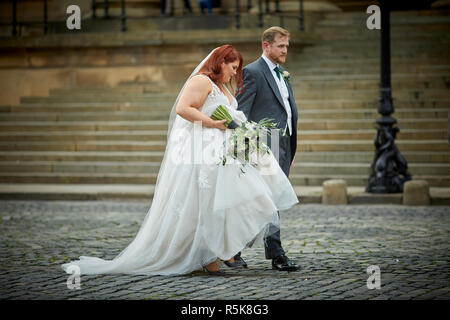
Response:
[0,201,450,300]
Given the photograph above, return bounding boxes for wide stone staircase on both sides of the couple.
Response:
[0,11,450,197]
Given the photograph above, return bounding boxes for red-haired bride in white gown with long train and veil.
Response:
[62,45,298,275]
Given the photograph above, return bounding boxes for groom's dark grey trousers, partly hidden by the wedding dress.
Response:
[264,129,295,259]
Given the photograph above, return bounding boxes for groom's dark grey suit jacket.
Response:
[236,57,298,165]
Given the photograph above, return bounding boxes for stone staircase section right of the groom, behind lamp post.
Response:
[290,11,450,187]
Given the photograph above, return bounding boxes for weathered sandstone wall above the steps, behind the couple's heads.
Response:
[0,30,312,105]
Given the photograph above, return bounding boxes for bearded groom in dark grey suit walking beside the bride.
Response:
[234,27,300,271]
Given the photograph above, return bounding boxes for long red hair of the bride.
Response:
[198,44,244,92]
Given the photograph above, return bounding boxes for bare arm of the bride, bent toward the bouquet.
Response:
[176,77,227,130]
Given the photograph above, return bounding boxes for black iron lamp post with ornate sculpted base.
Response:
[366,0,412,193]
